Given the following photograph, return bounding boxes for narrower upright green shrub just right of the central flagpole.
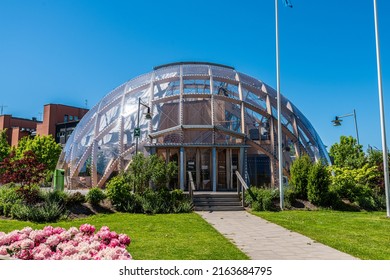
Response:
[290,155,313,199]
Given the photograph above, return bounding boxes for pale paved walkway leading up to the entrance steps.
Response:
[196,211,356,260]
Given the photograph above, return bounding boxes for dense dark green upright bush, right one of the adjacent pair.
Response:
[307,161,330,206]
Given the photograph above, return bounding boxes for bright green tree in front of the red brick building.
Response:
[16,135,61,171]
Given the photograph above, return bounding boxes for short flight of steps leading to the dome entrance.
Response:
[193,192,244,211]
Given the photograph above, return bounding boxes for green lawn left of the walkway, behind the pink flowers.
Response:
[0,213,248,260]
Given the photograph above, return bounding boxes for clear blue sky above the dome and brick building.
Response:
[0,0,390,153]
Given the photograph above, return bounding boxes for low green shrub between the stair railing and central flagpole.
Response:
[245,187,279,211]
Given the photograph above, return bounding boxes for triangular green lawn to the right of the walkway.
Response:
[253,210,390,260]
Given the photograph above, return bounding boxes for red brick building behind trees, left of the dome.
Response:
[0,104,88,146]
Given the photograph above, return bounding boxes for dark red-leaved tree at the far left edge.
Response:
[0,151,46,187]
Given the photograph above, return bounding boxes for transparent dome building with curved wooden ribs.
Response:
[57,62,330,191]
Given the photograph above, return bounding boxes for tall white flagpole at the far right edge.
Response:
[374,0,390,217]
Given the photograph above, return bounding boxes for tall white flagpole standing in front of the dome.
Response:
[275,0,284,210]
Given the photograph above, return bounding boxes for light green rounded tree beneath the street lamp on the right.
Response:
[329,136,366,169]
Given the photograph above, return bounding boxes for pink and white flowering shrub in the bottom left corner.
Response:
[0,224,131,260]
